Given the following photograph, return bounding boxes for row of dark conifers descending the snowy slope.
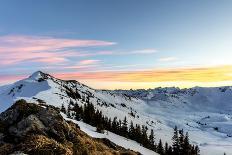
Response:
[61,98,200,155]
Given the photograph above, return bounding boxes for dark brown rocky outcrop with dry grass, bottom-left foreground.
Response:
[0,100,138,155]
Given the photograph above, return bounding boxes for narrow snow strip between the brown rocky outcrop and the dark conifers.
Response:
[61,113,158,155]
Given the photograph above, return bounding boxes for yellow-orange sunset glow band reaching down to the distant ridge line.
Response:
[47,66,232,89]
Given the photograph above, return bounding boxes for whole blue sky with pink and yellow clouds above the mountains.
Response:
[0,0,232,89]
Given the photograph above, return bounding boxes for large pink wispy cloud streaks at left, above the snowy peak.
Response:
[0,35,116,65]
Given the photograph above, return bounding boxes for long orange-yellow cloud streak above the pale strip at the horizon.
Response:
[52,66,232,82]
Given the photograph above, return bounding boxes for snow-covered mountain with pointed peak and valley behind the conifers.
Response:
[0,71,232,155]
